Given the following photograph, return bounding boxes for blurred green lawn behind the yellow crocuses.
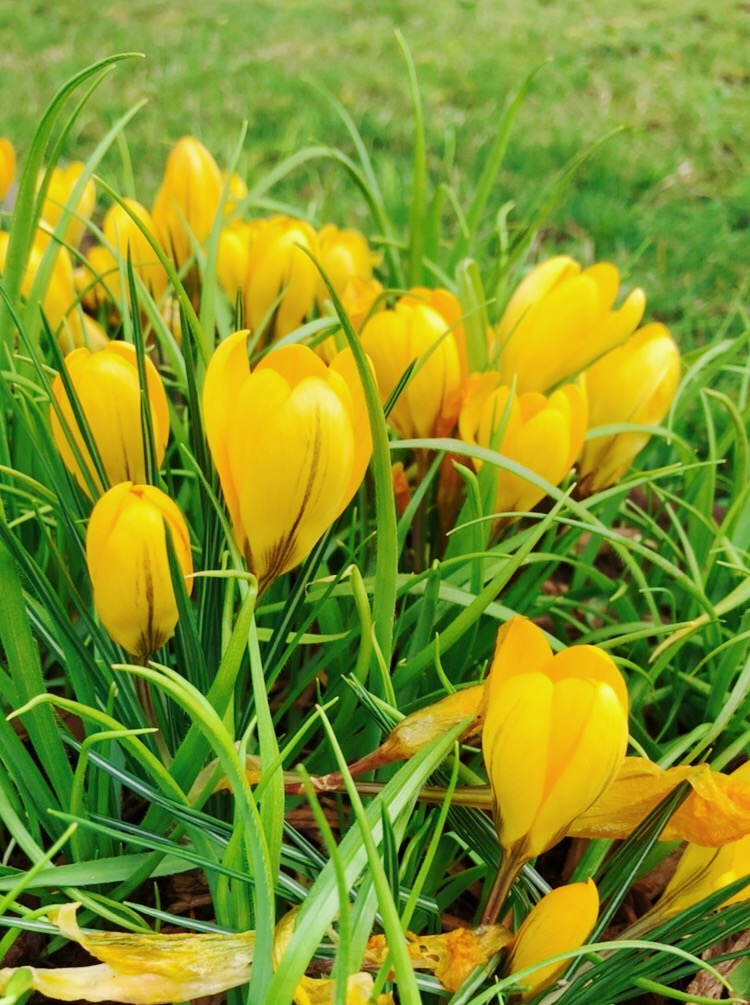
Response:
[0,0,750,342]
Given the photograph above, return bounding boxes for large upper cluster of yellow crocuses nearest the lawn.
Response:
[0,131,680,658]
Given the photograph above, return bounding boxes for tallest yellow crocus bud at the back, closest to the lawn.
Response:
[152,136,222,267]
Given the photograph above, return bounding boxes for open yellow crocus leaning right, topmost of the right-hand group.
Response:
[497,255,645,391]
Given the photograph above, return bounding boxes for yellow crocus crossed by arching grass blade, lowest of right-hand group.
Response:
[458,373,588,513]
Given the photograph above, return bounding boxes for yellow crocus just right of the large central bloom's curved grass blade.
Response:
[362,303,461,438]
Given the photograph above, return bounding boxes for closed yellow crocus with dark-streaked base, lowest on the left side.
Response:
[85,481,193,659]
